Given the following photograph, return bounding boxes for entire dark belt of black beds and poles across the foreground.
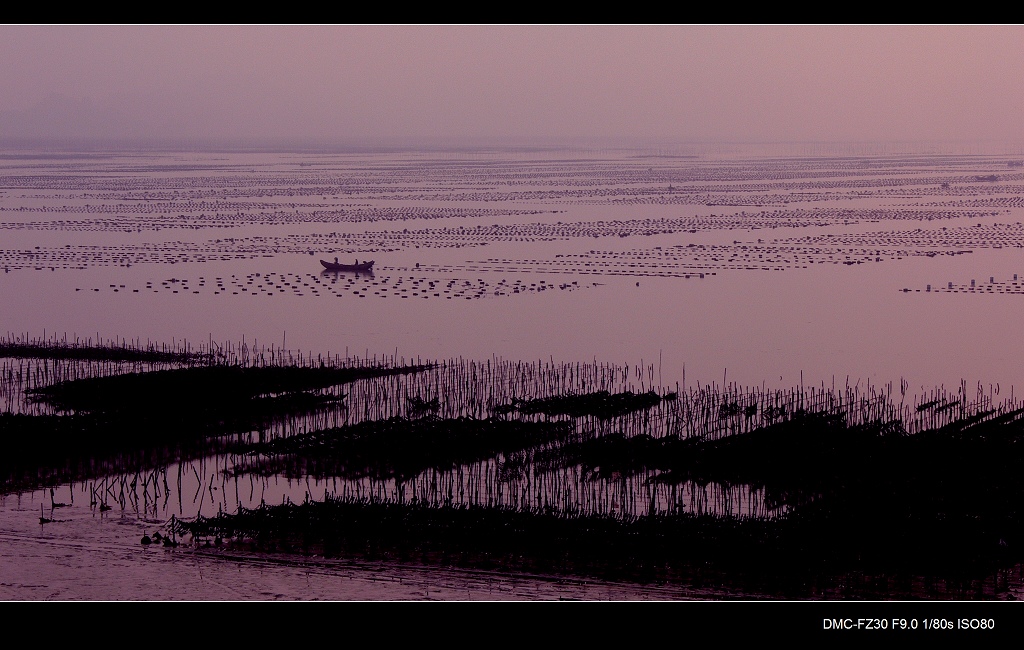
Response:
[0,339,1024,598]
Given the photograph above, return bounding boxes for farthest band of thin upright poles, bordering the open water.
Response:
[0,335,1020,439]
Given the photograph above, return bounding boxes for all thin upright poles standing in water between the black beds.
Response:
[8,337,1020,528]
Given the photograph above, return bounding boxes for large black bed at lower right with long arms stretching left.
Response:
[172,395,1024,597]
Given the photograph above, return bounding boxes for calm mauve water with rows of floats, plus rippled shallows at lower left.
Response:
[6,145,1024,600]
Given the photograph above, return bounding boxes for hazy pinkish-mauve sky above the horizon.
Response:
[0,25,1024,141]
